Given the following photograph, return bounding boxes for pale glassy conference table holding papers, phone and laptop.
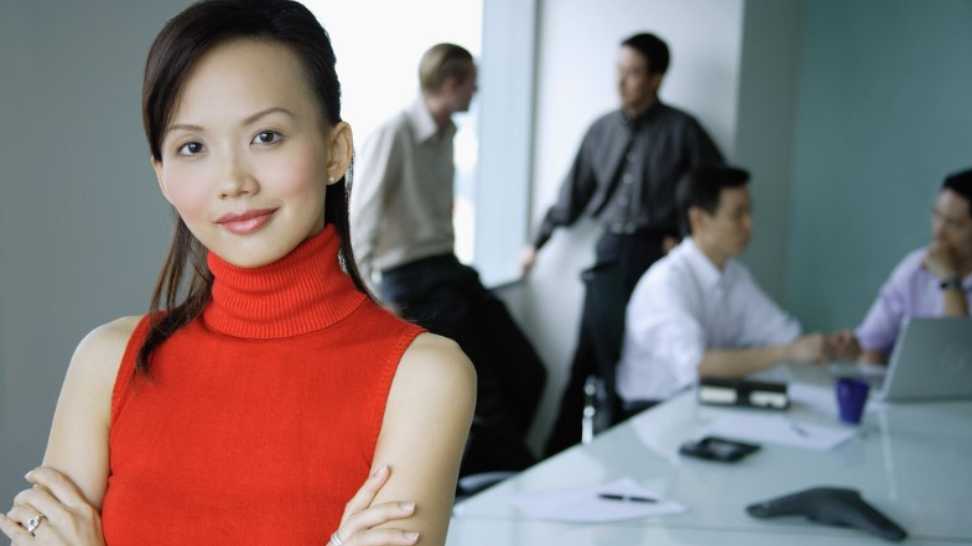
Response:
[447,365,972,546]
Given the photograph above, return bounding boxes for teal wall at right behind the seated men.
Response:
[786,0,972,329]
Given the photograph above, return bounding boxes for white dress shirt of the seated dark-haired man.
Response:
[617,238,800,401]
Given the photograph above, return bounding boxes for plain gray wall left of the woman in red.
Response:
[0,0,184,510]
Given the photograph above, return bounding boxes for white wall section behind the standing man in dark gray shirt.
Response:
[505,0,743,447]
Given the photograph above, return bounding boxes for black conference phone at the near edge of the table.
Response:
[746,487,908,542]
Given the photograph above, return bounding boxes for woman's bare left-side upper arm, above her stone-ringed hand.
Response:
[44,317,139,510]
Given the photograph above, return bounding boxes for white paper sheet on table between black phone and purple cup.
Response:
[703,413,855,450]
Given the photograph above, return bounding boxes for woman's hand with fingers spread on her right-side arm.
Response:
[327,466,419,546]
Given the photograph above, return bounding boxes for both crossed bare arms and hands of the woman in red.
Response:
[0,318,476,546]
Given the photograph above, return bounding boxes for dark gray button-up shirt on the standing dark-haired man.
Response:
[534,102,723,248]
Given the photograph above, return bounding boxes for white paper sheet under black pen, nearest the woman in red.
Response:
[513,478,685,523]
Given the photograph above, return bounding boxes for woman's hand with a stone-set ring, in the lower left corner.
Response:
[0,466,105,546]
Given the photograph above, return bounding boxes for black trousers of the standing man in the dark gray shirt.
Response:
[545,231,664,457]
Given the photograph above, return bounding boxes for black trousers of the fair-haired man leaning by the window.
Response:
[381,254,547,476]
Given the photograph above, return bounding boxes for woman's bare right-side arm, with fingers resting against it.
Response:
[366,334,476,546]
